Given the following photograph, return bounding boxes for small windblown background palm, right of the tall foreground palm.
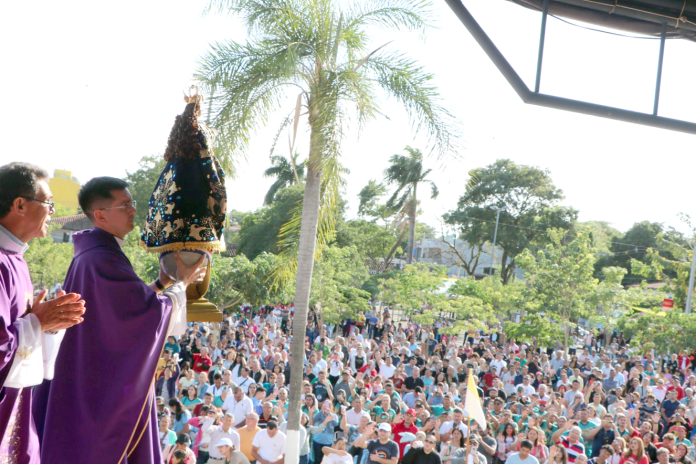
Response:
[384,147,439,264]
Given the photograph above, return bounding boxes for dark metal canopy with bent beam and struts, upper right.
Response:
[445,0,696,134]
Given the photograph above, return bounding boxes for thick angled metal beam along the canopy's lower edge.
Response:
[445,0,696,135]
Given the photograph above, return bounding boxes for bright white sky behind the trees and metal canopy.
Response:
[0,0,696,236]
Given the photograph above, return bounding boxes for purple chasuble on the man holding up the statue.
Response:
[35,229,172,464]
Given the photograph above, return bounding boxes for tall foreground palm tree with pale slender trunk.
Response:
[197,0,456,464]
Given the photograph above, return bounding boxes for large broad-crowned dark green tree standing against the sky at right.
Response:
[444,160,577,284]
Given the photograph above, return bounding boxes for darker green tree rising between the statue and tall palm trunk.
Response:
[238,185,304,260]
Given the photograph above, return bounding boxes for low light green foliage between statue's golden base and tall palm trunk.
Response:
[206,252,292,310]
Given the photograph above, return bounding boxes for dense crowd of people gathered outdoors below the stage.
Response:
[150,305,696,464]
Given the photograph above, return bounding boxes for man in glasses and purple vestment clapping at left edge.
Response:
[0,163,85,464]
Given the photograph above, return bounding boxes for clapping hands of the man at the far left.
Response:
[31,289,85,332]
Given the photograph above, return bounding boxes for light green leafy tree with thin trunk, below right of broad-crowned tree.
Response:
[517,229,597,350]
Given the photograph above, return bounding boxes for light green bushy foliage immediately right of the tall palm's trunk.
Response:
[310,246,370,323]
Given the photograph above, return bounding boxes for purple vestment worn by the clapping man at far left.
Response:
[0,245,40,464]
